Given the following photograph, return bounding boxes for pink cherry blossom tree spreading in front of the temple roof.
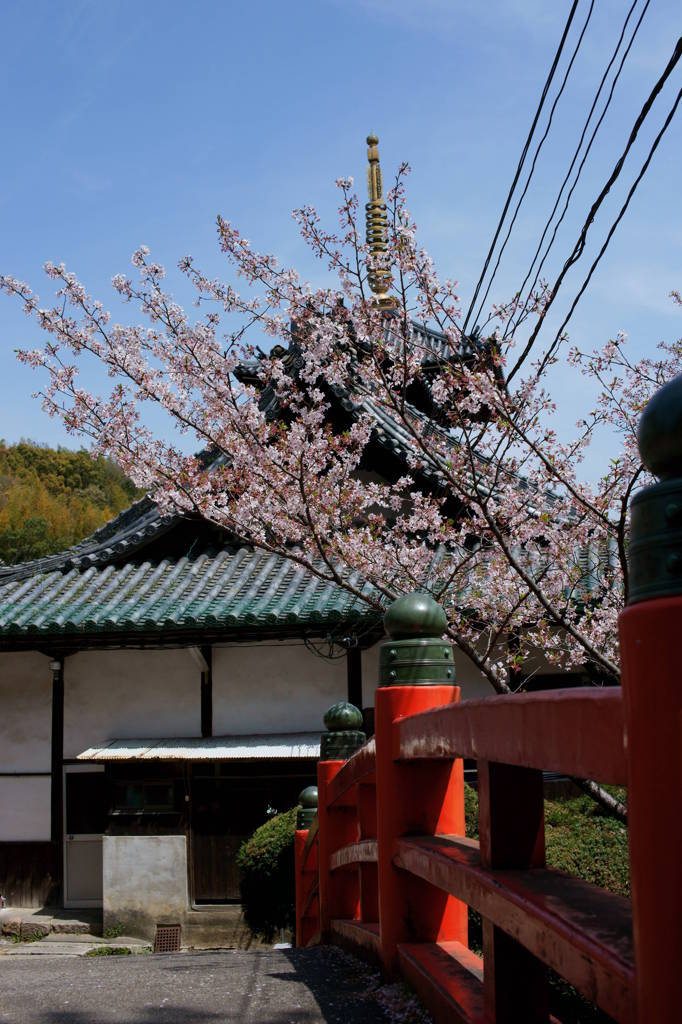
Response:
[0,165,682,823]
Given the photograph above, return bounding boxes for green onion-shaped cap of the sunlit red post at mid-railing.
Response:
[379,593,455,686]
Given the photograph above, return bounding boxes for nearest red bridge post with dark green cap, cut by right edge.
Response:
[620,375,682,1024]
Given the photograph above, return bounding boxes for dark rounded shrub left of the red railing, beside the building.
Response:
[237,807,298,942]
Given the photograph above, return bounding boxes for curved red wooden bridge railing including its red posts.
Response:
[296,585,682,1024]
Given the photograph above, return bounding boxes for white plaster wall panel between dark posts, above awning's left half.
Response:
[63,649,201,758]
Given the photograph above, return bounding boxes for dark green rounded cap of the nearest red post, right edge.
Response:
[628,374,682,604]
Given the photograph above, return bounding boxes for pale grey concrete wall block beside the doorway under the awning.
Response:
[102,836,189,939]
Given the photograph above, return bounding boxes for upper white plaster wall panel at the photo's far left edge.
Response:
[0,651,52,772]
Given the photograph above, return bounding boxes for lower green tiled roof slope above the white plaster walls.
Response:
[0,547,378,640]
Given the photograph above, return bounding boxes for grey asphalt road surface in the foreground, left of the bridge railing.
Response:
[0,946,387,1024]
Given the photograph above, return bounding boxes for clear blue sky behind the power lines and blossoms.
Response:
[0,0,682,472]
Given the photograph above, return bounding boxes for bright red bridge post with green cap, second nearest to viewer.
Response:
[368,594,467,975]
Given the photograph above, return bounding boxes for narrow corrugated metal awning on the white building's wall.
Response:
[78,732,319,761]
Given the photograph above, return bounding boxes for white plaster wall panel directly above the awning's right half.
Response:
[213,643,347,735]
